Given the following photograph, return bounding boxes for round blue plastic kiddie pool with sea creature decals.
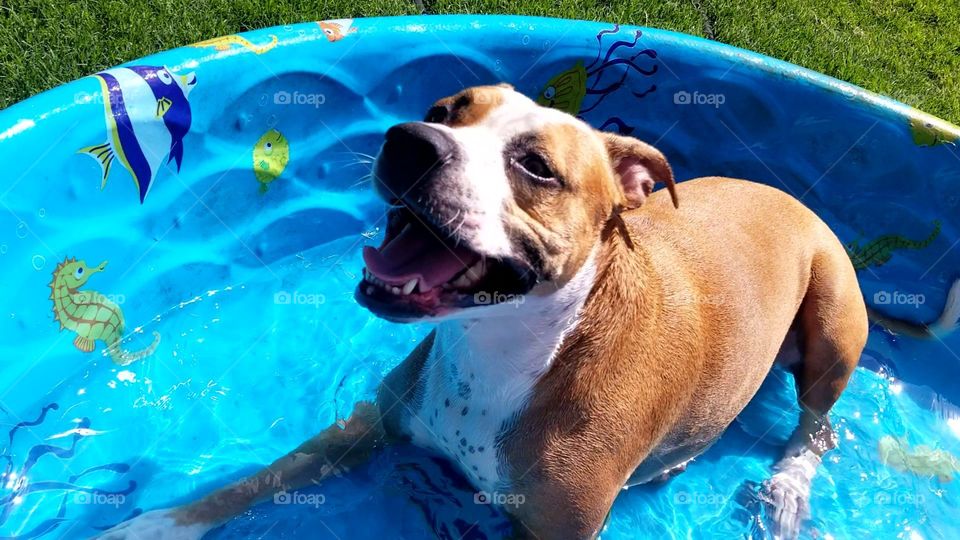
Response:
[0,16,960,539]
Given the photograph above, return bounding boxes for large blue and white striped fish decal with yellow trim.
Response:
[79,66,197,204]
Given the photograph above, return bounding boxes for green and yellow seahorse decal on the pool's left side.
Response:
[50,258,160,366]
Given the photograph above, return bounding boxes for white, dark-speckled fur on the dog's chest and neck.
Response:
[408,250,596,492]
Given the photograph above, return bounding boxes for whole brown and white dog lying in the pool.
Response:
[104,85,960,539]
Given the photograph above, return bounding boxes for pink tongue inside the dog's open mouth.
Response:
[363,224,477,291]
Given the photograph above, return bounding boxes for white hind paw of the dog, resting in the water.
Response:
[760,450,820,540]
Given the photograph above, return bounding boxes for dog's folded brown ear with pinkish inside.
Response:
[600,132,680,209]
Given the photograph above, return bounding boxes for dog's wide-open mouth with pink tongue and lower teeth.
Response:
[357,206,536,321]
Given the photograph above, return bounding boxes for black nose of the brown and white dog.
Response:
[375,122,456,197]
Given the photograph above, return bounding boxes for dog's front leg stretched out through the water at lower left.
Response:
[99,402,387,540]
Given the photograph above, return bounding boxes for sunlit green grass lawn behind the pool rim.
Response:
[0,0,960,122]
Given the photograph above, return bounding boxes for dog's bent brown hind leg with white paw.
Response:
[761,247,868,538]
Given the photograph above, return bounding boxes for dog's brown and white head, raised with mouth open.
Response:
[357,85,676,321]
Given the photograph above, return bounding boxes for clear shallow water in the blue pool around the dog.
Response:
[3,236,960,538]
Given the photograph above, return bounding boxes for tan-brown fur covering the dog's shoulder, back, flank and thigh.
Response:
[505,178,867,538]
